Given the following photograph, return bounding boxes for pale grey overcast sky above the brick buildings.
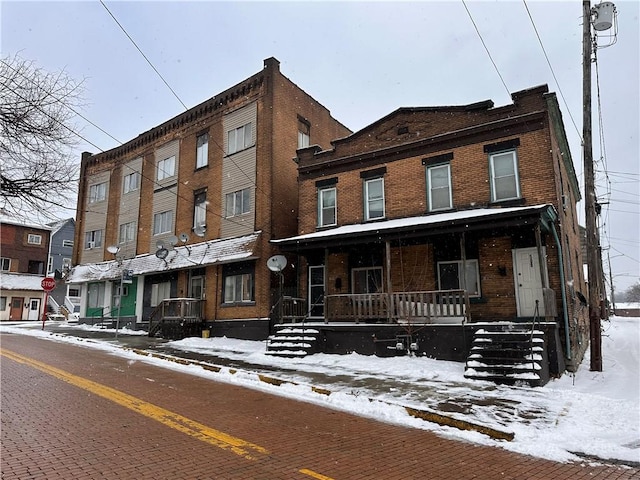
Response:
[0,0,640,291]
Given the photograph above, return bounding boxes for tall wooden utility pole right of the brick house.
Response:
[582,0,602,372]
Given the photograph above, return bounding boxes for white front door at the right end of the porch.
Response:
[513,247,546,317]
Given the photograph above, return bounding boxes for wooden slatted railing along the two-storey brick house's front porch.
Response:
[325,290,469,323]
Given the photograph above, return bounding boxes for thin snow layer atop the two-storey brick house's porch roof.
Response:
[271,204,554,245]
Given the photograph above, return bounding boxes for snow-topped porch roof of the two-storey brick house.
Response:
[271,204,557,250]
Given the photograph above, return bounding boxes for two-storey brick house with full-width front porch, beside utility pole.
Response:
[273,86,589,382]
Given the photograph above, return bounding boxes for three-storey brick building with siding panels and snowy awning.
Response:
[67,58,351,339]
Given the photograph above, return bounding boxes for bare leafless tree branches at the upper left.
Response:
[0,56,81,218]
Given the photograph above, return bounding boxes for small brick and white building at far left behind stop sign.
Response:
[0,215,51,320]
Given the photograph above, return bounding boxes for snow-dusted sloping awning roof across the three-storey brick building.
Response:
[67,232,262,283]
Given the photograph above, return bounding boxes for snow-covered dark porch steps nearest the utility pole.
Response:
[464,324,549,386]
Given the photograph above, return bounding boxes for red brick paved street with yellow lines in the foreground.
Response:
[0,334,640,480]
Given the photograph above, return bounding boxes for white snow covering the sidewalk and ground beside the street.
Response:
[0,317,640,466]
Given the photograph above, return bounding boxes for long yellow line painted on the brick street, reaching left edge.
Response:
[0,349,268,462]
